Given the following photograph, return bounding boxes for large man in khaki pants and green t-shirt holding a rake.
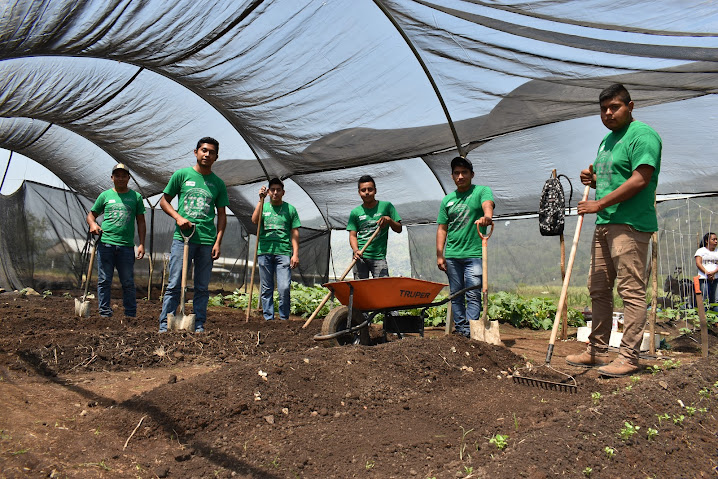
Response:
[566,84,662,377]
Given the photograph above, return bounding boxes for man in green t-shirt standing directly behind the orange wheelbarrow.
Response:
[347,175,402,279]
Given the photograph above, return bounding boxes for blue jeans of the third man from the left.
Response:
[257,254,292,320]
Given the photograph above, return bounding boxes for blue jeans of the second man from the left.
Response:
[160,239,214,332]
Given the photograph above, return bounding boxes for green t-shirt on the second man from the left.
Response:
[163,167,229,245]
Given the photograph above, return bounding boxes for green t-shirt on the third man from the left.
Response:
[257,201,301,256]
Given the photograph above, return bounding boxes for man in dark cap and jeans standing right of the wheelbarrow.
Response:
[436,156,494,338]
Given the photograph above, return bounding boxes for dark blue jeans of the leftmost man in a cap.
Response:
[97,242,137,317]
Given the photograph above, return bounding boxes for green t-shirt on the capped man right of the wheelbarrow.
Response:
[436,185,494,258]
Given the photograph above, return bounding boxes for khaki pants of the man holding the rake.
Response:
[588,224,651,364]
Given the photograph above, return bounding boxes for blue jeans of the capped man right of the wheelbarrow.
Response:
[446,258,483,337]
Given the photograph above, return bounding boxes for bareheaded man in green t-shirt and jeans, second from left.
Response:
[160,137,229,333]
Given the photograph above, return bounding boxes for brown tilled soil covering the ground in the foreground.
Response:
[0,293,718,479]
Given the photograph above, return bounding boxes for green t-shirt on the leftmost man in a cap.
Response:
[92,189,145,246]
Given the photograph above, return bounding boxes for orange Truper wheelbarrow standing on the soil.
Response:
[314,277,481,346]
